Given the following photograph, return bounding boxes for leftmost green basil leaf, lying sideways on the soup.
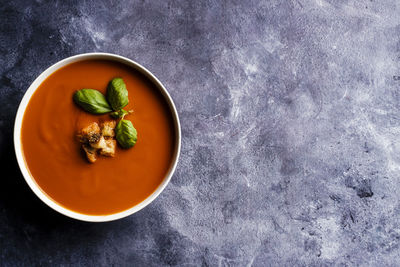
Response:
[73,89,112,114]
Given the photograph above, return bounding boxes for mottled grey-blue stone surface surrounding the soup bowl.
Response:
[0,0,400,266]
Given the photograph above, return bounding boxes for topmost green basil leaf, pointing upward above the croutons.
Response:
[107,78,129,111]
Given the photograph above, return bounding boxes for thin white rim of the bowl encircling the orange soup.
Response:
[14,52,181,222]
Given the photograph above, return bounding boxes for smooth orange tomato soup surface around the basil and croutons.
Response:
[21,60,175,215]
